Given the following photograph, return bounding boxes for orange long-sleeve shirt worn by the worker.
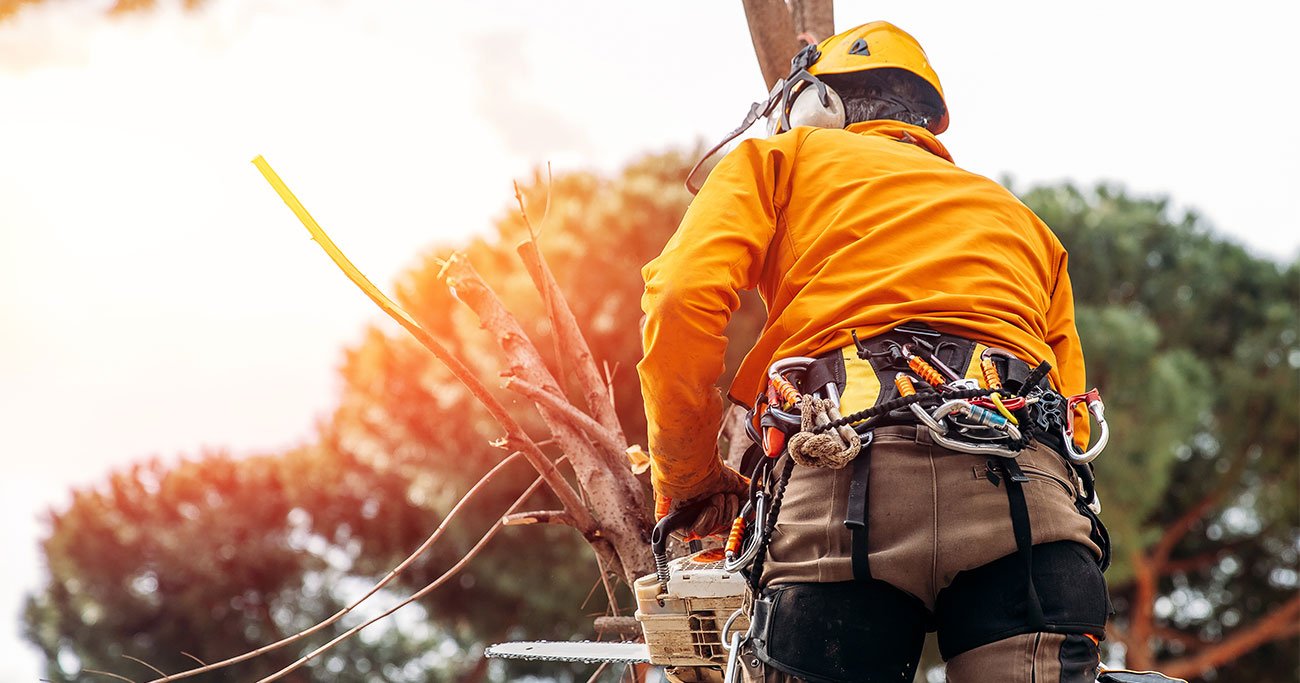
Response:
[637,121,1087,498]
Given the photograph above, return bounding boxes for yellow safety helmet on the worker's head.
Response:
[806,21,948,134]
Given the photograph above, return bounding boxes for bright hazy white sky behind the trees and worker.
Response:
[0,0,1300,682]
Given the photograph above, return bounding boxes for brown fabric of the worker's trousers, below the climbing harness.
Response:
[741,425,1105,683]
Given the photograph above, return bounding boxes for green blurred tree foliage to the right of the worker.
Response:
[1024,186,1300,680]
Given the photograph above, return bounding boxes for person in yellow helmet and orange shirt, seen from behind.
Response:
[638,22,1109,683]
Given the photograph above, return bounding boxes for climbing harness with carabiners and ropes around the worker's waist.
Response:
[723,324,1109,682]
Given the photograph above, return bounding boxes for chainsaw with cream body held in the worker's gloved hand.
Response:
[485,501,749,683]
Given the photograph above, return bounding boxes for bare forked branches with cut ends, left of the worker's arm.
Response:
[254,156,654,584]
